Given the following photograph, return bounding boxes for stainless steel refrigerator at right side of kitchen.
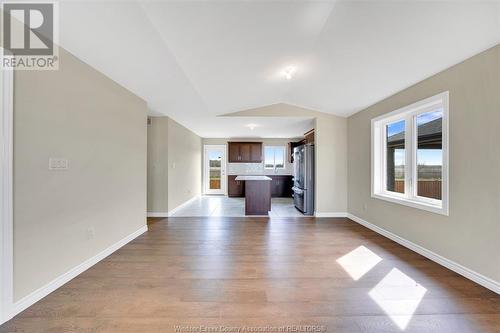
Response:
[292,144,314,215]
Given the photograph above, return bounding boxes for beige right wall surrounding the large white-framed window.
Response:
[348,46,500,281]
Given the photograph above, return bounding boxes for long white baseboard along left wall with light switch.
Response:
[10,225,148,318]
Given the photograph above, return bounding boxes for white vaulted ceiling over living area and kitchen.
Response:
[56,0,500,137]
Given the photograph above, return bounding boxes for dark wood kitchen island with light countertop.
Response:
[236,176,271,215]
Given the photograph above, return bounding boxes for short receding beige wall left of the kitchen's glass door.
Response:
[168,118,202,211]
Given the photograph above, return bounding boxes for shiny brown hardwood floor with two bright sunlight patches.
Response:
[0,217,500,333]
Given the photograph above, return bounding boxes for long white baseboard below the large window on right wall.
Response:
[347,213,500,294]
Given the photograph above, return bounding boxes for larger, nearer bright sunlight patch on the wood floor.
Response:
[369,268,427,330]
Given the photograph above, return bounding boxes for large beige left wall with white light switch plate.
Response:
[14,48,147,301]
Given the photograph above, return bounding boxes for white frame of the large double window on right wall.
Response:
[371,91,449,216]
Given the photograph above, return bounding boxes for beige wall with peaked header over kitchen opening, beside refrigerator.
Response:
[225,103,347,214]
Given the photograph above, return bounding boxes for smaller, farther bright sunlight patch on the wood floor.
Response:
[337,245,382,281]
